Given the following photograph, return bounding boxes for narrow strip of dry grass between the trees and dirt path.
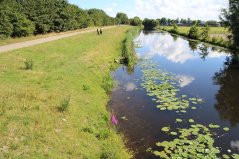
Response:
[0,27,96,46]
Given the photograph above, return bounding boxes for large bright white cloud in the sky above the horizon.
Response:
[135,0,228,20]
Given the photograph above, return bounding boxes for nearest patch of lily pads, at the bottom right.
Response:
[153,119,239,159]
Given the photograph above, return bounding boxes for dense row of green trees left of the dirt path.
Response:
[0,0,141,38]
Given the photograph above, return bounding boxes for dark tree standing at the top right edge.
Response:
[220,0,239,48]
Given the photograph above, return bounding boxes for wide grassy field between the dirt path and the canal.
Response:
[0,26,131,159]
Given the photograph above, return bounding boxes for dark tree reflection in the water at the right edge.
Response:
[213,54,239,127]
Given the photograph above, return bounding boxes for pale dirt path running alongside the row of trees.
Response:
[0,26,115,53]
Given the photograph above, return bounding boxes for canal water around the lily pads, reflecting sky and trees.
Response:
[109,31,239,159]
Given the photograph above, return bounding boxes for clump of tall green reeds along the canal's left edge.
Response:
[123,27,141,66]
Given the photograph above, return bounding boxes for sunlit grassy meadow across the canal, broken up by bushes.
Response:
[159,26,235,49]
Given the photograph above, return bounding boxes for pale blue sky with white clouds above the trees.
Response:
[68,0,228,20]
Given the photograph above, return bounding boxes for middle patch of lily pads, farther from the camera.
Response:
[141,62,203,113]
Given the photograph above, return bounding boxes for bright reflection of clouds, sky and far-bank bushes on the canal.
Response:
[135,31,228,64]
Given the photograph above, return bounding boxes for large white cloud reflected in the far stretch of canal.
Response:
[136,33,225,64]
